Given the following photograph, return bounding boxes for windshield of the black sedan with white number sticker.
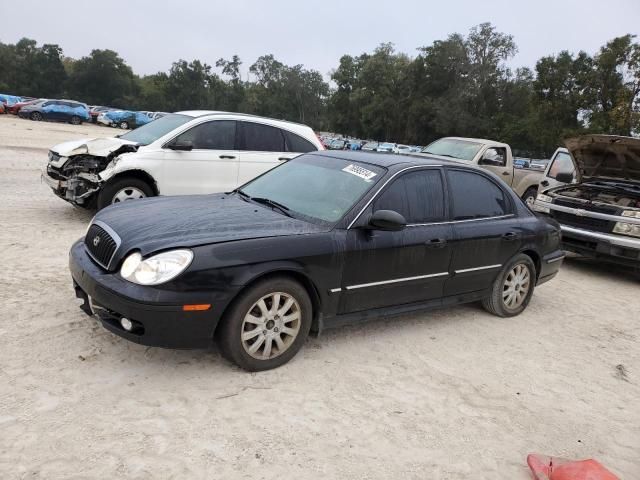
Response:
[238,155,385,223]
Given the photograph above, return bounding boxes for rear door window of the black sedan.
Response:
[447,170,509,220]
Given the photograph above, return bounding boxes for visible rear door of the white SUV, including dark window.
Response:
[238,121,296,185]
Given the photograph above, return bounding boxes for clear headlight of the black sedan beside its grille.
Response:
[120,250,193,285]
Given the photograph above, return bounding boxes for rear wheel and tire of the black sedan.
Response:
[482,253,536,317]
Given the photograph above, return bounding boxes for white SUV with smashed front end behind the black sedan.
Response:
[42,111,324,209]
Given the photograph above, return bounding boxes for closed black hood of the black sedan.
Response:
[94,194,331,257]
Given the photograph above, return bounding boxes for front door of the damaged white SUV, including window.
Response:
[159,120,238,195]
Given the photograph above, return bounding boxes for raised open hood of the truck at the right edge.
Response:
[564,135,640,181]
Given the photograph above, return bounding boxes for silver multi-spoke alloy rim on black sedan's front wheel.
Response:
[241,292,302,360]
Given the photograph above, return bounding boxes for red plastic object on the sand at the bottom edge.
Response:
[527,453,620,480]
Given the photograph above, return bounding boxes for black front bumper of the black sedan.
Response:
[69,240,241,348]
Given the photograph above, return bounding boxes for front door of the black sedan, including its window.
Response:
[340,168,452,313]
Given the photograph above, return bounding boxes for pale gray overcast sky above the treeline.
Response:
[0,0,640,79]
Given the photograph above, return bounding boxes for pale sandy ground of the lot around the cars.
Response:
[0,116,640,480]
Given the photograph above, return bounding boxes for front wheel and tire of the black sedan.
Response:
[216,277,313,372]
